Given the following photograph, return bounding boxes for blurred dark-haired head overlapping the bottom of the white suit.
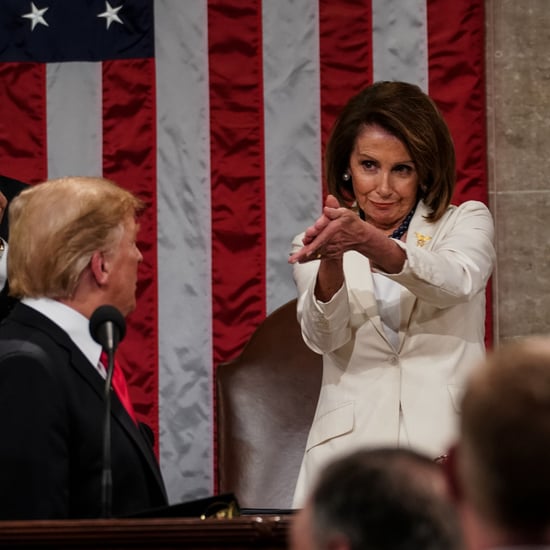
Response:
[290,448,462,550]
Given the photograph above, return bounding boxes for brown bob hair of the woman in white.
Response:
[325,81,456,222]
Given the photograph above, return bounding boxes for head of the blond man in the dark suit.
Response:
[8,177,143,316]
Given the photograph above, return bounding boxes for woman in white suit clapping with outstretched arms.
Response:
[289,82,495,507]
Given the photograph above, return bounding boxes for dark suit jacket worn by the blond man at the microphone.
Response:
[0,303,167,519]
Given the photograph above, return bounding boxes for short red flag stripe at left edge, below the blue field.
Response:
[0,63,48,183]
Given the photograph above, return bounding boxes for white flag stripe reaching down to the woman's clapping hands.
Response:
[262,0,322,313]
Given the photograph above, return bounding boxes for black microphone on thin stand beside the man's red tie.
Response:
[90,305,126,518]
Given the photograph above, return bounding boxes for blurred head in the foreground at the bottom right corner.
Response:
[447,336,550,550]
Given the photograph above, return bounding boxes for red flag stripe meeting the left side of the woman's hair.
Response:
[319,0,372,191]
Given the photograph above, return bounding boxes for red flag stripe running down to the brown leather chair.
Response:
[208,0,266,365]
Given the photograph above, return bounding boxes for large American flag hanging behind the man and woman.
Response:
[0,0,490,502]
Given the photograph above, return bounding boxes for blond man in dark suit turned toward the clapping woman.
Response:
[0,177,167,519]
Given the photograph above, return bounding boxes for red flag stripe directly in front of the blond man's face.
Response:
[103,59,161,448]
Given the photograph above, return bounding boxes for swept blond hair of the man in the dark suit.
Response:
[8,177,144,299]
